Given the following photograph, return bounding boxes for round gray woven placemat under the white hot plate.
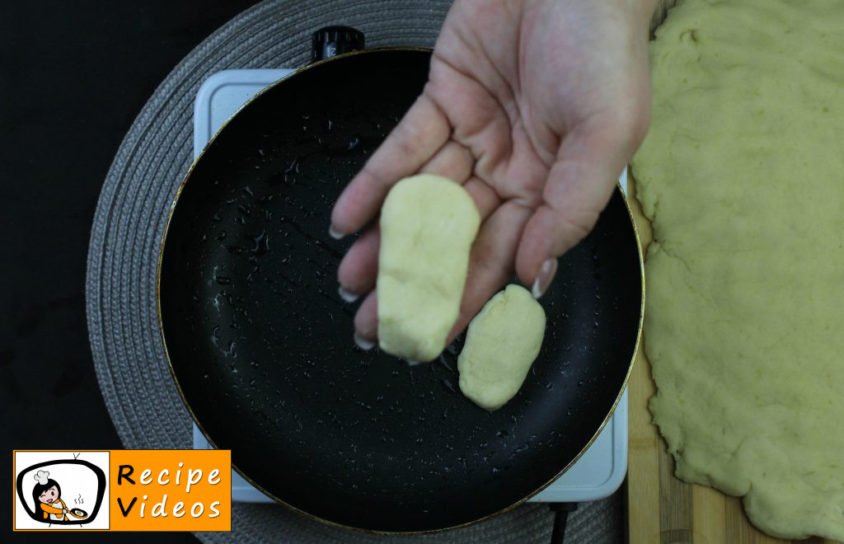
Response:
[86,0,623,544]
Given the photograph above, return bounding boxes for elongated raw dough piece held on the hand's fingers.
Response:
[378,174,481,361]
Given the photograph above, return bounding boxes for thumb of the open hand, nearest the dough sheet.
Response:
[516,113,647,298]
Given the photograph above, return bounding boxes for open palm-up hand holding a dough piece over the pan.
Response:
[331,0,654,345]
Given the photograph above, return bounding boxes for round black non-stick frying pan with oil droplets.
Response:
[159,28,643,532]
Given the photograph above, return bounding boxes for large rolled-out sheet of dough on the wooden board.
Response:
[633,0,844,540]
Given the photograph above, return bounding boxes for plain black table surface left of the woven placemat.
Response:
[0,0,255,544]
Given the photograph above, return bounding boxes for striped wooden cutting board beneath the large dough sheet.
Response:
[627,181,833,544]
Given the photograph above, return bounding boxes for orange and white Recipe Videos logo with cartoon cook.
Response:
[12,450,231,531]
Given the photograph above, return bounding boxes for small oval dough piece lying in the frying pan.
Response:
[457,285,545,410]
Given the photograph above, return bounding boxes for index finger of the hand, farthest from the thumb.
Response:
[331,94,451,236]
